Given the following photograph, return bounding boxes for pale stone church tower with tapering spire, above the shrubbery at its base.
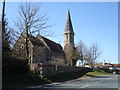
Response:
[64,10,74,51]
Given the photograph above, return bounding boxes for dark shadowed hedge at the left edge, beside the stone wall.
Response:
[2,55,28,73]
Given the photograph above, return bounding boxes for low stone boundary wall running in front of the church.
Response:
[30,63,82,77]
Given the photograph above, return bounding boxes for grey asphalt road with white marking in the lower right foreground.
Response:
[39,75,118,88]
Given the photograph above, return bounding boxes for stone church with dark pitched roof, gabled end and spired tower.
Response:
[13,11,74,65]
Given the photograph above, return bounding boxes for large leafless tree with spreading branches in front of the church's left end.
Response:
[13,2,50,62]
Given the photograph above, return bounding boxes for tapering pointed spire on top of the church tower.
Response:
[64,10,73,33]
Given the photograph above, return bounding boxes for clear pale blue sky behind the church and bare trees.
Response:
[0,2,118,63]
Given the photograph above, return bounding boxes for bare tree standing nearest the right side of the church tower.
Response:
[77,40,87,66]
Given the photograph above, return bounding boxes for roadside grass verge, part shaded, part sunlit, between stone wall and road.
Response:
[47,70,112,82]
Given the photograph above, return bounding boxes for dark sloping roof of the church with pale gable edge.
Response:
[29,34,63,53]
